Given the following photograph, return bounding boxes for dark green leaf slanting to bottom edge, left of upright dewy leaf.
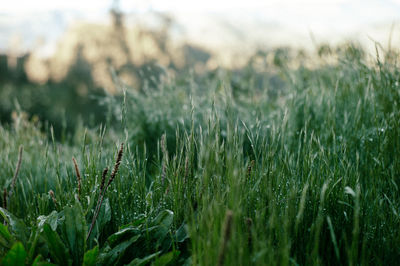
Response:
[42,224,71,265]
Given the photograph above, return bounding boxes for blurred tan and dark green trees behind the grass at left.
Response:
[0,8,210,140]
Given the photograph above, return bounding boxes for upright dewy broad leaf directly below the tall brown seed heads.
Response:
[63,202,86,265]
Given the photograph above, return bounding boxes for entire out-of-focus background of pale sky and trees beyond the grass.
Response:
[0,0,400,137]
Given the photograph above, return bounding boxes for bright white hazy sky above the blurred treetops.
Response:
[0,0,400,55]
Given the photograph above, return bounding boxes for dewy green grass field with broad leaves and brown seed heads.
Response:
[0,45,400,265]
